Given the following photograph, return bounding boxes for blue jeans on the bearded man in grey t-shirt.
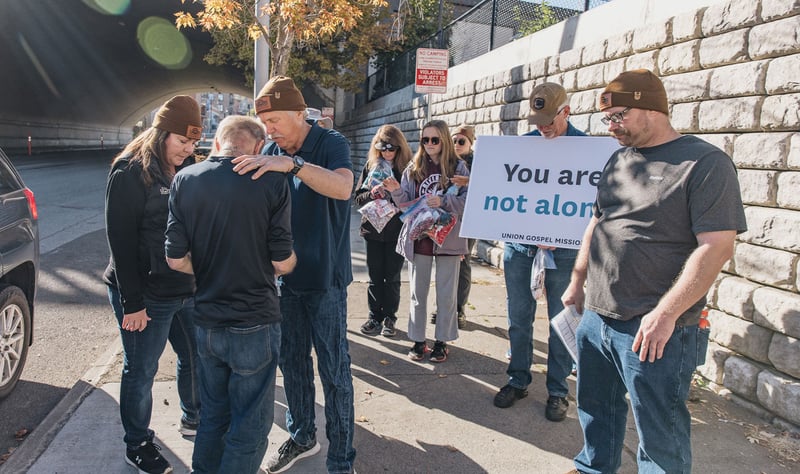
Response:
[575,310,706,474]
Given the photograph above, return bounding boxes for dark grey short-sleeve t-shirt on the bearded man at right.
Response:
[586,136,747,324]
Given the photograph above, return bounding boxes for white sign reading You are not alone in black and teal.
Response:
[460,136,620,248]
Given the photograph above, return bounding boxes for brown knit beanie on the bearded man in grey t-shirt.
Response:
[597,69,669,115]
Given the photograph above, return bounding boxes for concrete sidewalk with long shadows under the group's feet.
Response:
[0,214,798,474]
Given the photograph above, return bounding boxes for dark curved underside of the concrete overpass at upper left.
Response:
[0,0,252,151]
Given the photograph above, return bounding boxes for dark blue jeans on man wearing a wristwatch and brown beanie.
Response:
[279,286,356,473]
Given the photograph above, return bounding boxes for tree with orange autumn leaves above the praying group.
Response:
[175,0,386,86]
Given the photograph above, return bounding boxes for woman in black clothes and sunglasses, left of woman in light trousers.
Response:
[354,125,411,337]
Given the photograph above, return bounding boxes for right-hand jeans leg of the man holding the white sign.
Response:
[544,249,578,398]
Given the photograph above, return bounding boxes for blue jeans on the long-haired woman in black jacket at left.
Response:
[107,286,200,447]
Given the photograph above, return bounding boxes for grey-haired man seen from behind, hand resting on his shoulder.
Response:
[165,115,295,474]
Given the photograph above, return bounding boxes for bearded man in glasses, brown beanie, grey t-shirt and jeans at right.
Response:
[562,69,746,473]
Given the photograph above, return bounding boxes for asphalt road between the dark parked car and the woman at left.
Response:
[0,150,118,461]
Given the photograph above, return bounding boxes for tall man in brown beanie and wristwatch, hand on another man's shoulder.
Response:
[233,76,356,473]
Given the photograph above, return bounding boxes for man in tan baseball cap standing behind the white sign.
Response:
[494,82,586,421]
